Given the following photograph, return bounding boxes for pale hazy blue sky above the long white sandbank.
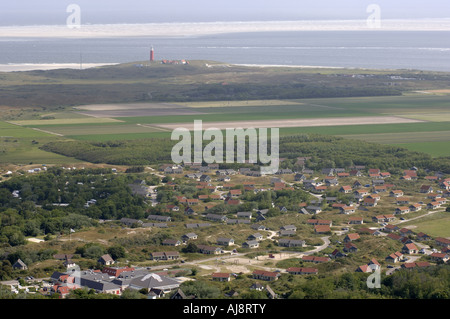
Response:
[0,0,450,25]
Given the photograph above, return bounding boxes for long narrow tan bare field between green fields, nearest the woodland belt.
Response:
[158,116,422,130]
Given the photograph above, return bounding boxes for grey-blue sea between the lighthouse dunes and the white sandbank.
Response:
[0,30,450,72]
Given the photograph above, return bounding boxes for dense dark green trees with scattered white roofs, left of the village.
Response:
[0,168,147,246]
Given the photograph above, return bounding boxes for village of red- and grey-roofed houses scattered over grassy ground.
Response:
[3,158,450,298]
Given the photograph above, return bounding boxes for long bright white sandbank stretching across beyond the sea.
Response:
[0,19,450,39]
